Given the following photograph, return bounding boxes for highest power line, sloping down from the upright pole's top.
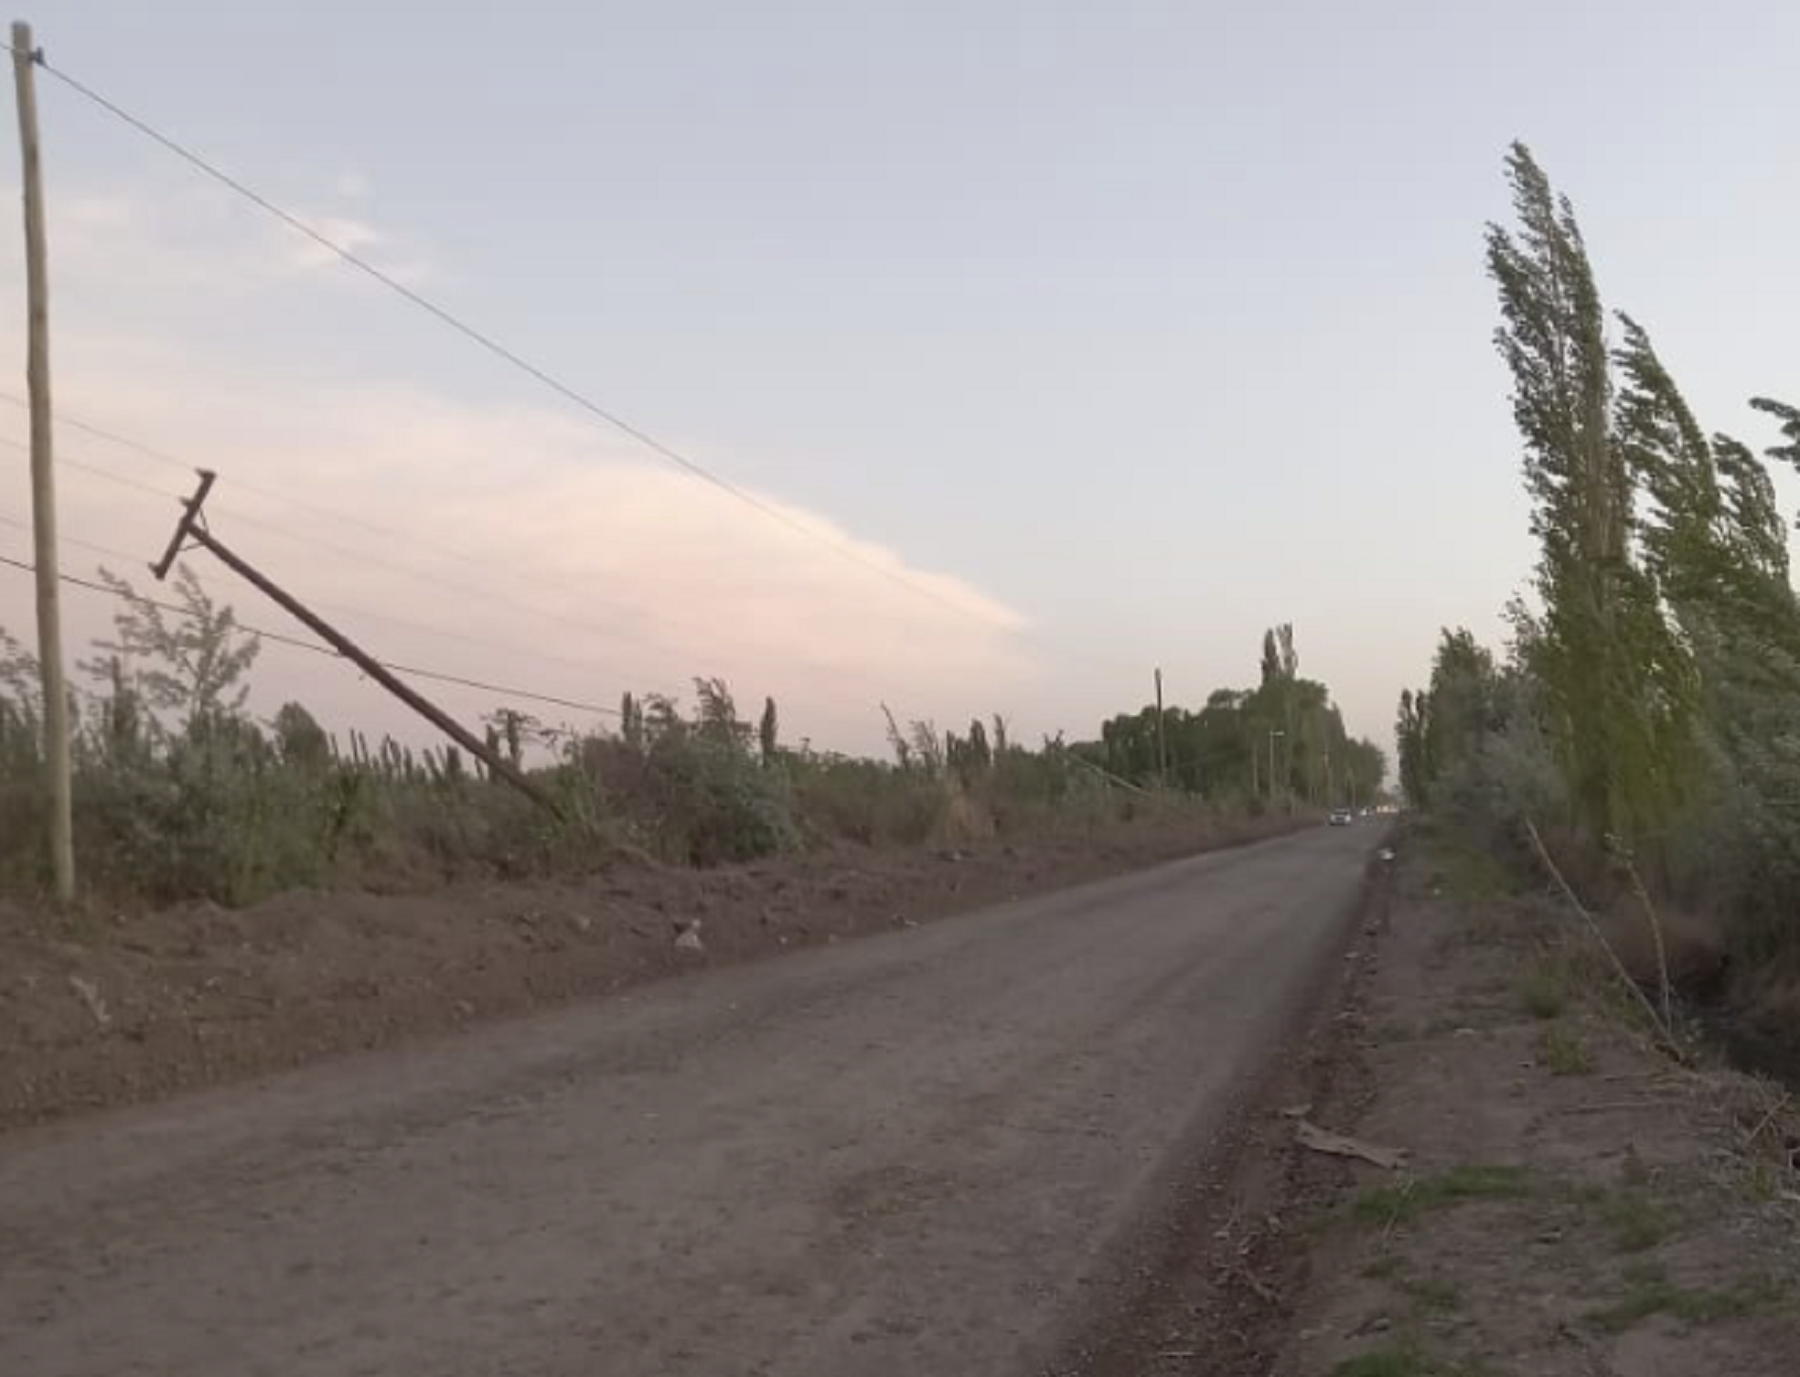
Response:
[29,49,1015,625]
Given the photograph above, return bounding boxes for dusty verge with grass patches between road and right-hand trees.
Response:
[1094,828,1800,1377]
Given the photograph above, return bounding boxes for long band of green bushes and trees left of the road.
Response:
[0,569,1384,905]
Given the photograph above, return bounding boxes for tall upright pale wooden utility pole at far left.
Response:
[13,22,76,904]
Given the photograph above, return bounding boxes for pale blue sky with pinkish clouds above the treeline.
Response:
[0,0,1800,749]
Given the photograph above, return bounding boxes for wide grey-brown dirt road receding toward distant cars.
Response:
[0,828,1373,1377]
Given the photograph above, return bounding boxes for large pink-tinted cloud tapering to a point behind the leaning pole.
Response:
[17,376,1035,749]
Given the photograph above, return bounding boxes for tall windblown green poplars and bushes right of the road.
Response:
[1397,146,1800,1044]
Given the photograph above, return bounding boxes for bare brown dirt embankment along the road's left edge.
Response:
[0,819,1292,1129]
